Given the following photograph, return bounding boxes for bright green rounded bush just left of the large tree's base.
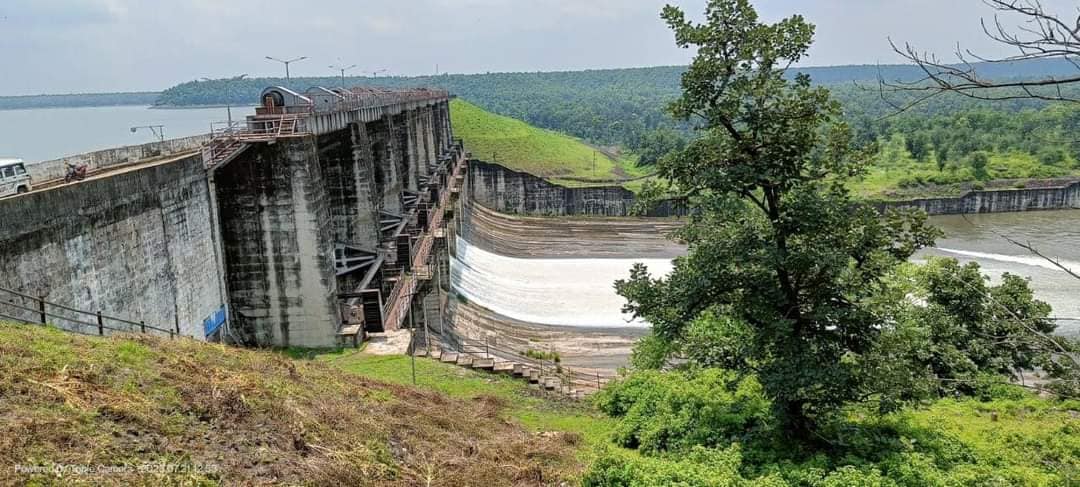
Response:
[595,369,770,454]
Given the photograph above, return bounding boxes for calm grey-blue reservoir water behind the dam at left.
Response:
[0,107,236,162]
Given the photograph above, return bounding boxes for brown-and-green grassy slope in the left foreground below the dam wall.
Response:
[0,325,603,486]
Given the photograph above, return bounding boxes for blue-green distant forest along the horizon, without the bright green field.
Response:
[156,60,1080,168]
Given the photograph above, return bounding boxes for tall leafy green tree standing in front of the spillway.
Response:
[617,0,935,442]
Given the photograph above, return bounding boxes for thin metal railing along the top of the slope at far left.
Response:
[0,288,179,338]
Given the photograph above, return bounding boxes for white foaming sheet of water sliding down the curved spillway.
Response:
[450,238,673,328]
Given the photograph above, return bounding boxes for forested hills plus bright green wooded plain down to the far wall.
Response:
[157,60,1080,198]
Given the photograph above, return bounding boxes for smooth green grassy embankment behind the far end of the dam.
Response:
[450,98,650,189]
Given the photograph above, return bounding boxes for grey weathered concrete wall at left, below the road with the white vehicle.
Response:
[0,155,225,339]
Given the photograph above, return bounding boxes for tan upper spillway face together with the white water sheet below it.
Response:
[450,199,684,328]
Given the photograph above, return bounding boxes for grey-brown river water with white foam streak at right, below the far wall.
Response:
[916,209,1080,335]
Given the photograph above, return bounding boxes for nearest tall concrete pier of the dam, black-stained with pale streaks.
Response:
[214,136,339,347]
